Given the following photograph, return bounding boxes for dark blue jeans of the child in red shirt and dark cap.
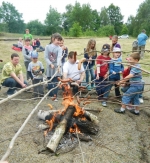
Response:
[95,77,109,99]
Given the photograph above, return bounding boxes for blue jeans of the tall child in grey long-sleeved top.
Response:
[47,76,58,97]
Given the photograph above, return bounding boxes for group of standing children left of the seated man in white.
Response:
[22,33,68,101]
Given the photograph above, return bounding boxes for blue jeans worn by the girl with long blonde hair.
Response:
[84,65,95,87]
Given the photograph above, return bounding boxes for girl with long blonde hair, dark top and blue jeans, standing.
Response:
[83,39,97,90]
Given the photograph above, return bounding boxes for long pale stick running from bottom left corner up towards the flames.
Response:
[1,79,61,161]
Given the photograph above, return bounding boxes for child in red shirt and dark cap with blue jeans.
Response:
[96,44,111,106]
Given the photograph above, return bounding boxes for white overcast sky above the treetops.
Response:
[0,0,144,23]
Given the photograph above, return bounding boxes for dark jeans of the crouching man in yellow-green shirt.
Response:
[2,78,27,95]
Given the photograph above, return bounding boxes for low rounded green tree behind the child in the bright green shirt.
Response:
[26,20,45,35]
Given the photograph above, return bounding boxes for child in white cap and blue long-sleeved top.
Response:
[109,48,124,97]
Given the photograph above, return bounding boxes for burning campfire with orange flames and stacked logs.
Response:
[38,78,98,152]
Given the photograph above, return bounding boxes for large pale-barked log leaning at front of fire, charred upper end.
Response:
[47,105,75,152]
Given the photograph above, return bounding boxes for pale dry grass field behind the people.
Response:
[0,34,150,76]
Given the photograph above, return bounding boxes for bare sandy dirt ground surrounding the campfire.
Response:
[0,78,150,163]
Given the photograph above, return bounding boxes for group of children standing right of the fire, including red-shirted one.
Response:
[84,36,144,115]
